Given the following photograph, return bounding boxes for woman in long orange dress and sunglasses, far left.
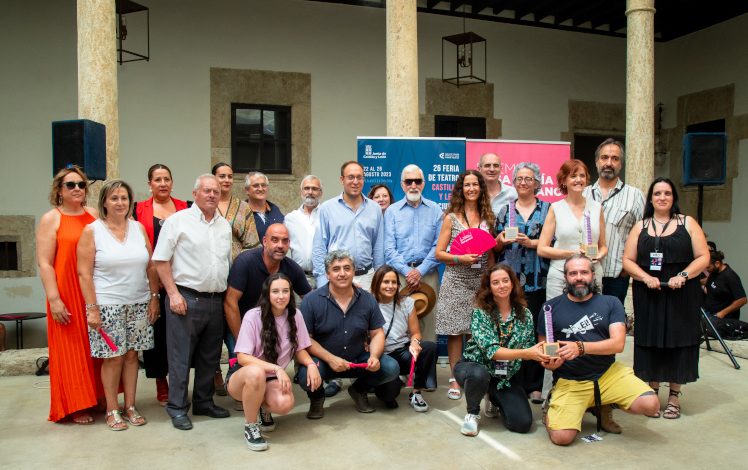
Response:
[36,166,104,424]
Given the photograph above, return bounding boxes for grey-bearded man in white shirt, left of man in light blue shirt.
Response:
[283,175,322,289]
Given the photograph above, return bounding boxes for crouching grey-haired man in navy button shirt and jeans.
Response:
[298,250,400,419]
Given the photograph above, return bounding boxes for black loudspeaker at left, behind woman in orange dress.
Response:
[52,119,106,181]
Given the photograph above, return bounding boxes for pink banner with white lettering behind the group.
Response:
[465,140,571,202]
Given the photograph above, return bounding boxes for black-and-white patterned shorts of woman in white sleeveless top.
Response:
[88,302,154,359]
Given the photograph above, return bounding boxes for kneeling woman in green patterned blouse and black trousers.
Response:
[455,264,548,436]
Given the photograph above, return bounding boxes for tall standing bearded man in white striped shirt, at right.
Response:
[583,138,644,303]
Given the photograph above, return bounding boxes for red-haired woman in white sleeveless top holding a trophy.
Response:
[538,158,608,300]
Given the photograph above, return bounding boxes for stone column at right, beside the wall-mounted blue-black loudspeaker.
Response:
[626,0,655,194]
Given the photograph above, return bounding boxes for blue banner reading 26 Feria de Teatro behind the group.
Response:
[357,137,465,209]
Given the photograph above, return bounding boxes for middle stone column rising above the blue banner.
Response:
[387,0,418,137]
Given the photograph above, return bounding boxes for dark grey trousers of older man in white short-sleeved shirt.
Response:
[165,287,223,417]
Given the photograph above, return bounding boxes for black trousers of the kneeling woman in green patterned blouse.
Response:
[454,361,532,433]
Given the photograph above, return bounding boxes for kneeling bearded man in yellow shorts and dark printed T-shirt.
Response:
[537,254,660,445]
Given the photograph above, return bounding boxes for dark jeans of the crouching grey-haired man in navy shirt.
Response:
[296,352,400,400]
